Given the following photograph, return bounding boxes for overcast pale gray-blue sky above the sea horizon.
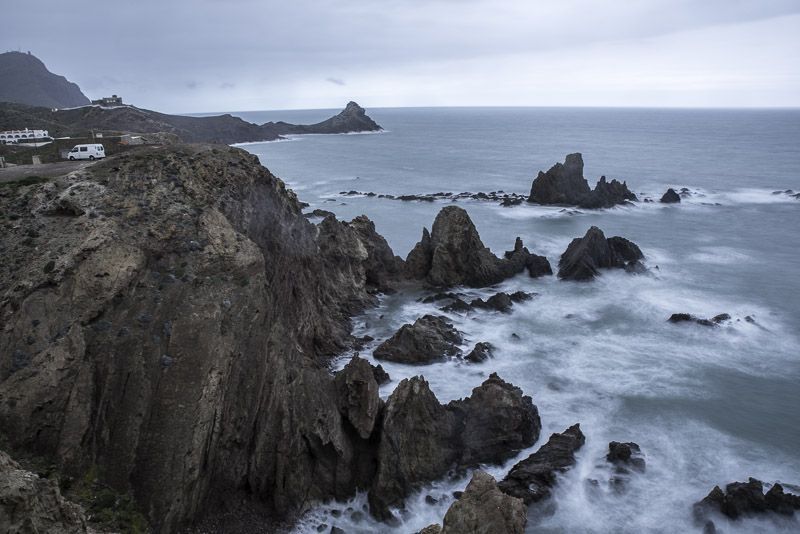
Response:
[0,0,800,113]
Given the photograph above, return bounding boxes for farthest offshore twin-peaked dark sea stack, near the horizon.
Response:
[528,153,636,209]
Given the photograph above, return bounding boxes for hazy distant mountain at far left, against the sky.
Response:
[0,52,89,110]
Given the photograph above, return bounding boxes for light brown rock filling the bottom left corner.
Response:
[0,451,88,534]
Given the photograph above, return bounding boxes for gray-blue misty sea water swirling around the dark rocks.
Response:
[233,108,800,533]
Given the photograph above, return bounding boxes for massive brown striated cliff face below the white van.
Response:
[0,146,388,531]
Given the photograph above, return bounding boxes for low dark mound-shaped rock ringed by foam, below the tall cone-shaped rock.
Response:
[373,315,463,364]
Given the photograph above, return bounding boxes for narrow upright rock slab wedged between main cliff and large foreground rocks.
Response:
[336,356,383,439]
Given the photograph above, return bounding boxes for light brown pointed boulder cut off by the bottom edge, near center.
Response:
[441,471,528,534]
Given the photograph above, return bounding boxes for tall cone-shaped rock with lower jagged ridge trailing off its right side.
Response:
[406,206,549,287]
